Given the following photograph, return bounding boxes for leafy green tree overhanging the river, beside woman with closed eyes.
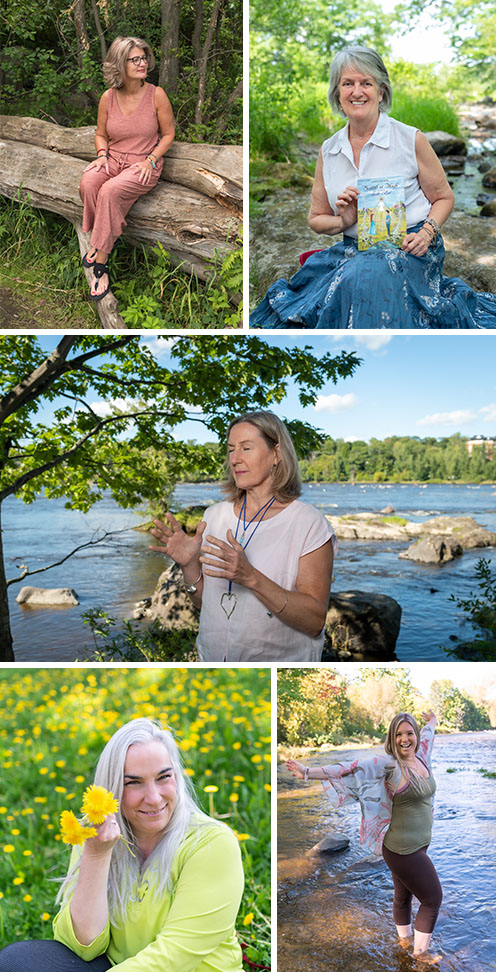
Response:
[0,335,359,661]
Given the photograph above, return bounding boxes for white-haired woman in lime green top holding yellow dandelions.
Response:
[0,719,243,972]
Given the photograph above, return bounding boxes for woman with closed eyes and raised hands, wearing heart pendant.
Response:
[152,411,336,662]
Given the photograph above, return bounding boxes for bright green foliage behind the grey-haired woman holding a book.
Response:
[250,0,496,161]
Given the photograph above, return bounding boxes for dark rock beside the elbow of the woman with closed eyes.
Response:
[322,591,401,661]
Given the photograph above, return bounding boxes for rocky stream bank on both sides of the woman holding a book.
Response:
[250,102,496,305]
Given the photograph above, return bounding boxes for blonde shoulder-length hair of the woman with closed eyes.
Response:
[222,410,301,503]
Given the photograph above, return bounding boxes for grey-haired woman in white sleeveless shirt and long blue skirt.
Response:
[250,47,496,328]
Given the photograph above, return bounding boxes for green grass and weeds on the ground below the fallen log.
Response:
[0,196,243,329]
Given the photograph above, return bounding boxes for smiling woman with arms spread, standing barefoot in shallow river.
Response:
[286,711,442,963]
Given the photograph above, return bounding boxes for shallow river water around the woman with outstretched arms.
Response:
[278,731,496,972]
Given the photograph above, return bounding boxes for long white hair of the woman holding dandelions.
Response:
[57,719,218,925]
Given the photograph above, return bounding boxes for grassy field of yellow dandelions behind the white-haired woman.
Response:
[0,667,270,966]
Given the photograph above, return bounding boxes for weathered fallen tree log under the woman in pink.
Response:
[0,115,242,329]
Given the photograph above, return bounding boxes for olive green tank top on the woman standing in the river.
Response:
[384,773,436,854]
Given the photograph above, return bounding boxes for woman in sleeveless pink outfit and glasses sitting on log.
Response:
[79,37,174,300]
